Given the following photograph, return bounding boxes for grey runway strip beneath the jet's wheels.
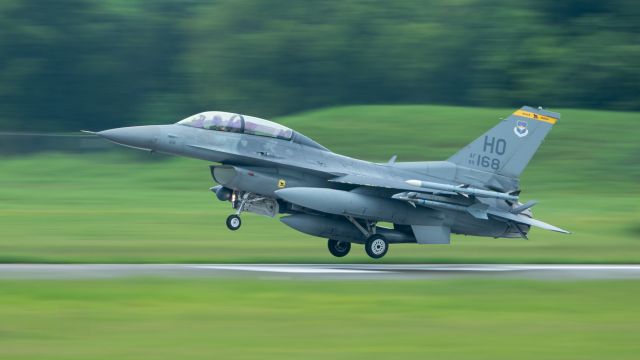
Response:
[0,264,640,280]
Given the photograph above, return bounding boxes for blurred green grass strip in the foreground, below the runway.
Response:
[0,278,640,360]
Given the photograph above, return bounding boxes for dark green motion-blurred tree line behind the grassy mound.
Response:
[0,0,640,130]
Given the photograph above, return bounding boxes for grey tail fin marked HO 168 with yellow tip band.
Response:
[448,106,560,178]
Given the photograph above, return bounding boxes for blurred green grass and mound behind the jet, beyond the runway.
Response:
[0,106,640,263]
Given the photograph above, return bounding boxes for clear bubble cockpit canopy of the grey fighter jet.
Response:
[178,111,293,140]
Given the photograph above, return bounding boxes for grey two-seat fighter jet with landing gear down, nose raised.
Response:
[86,106,568,259]
